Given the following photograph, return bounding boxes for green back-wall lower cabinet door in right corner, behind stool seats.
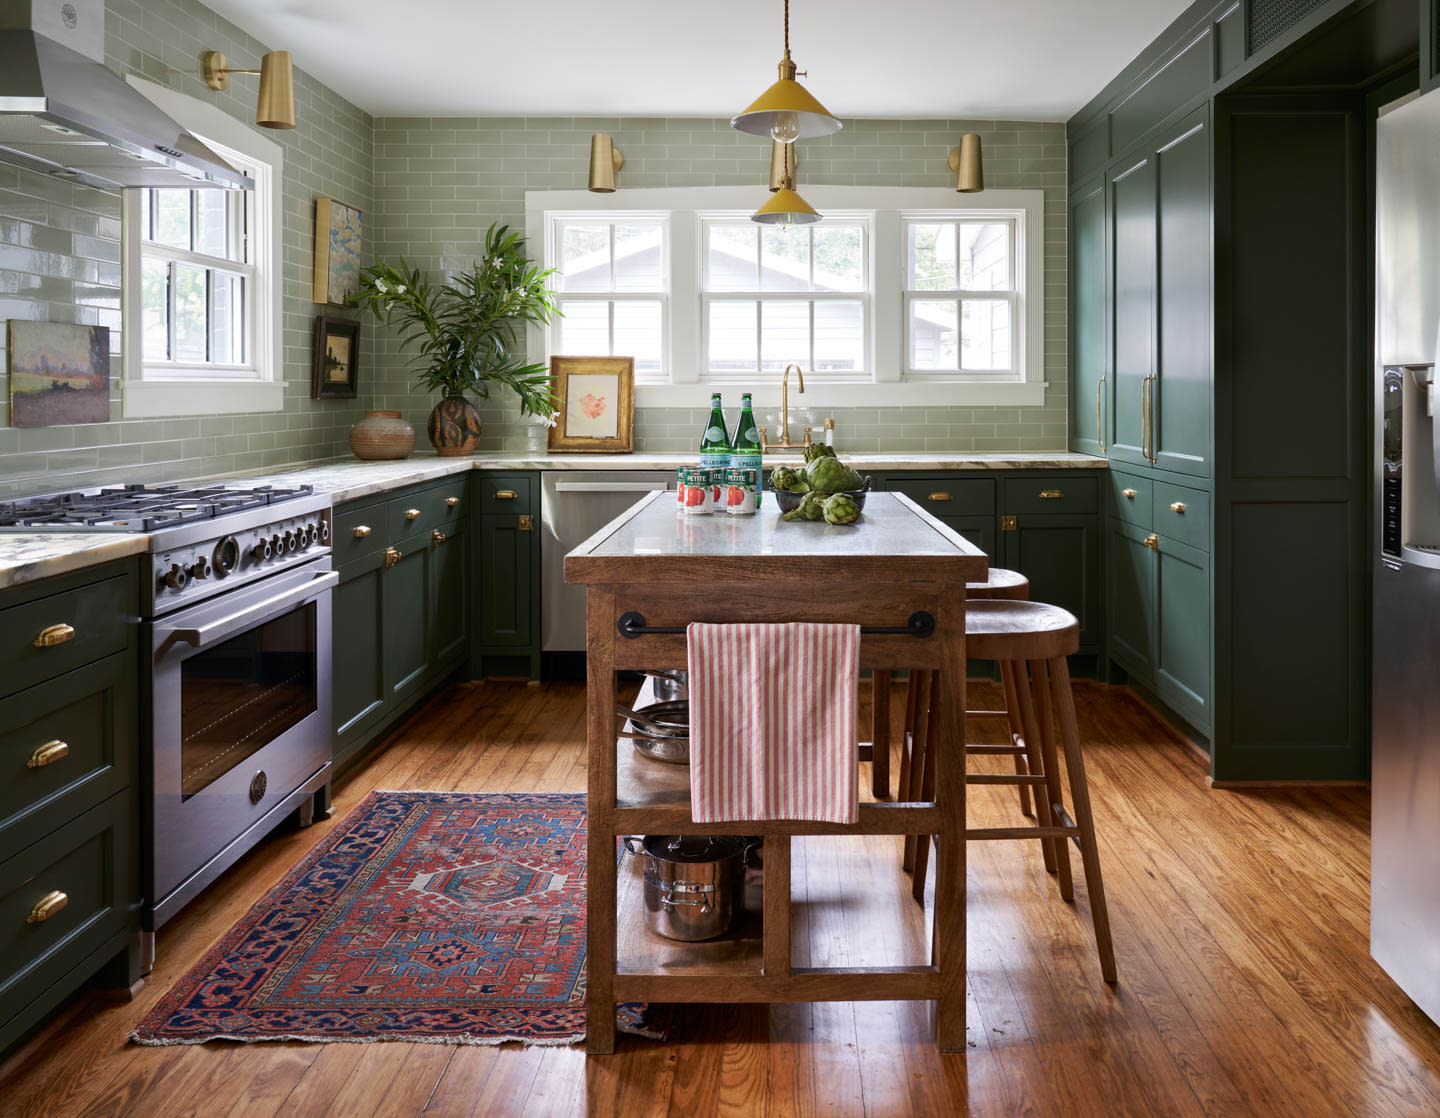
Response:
[1001,516,1100,651]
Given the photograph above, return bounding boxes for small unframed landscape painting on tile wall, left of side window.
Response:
[6,318,109,426]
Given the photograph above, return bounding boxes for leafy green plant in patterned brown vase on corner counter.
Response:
[350,223,557,455]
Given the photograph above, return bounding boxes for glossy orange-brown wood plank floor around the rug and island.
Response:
[0,683,1440,1118]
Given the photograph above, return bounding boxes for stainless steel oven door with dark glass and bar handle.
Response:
[147,556,340,905]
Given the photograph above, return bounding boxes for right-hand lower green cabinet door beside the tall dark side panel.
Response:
[1153,537,1211,730]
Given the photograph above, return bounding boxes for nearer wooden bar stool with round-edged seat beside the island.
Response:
[910,601,1116,983]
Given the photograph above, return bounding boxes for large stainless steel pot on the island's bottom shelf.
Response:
[625,834,750,942]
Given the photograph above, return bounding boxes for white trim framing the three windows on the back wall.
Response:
[526,184,1045,408]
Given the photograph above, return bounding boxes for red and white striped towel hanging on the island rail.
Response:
[685,622,860,823]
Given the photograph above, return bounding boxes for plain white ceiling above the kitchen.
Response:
[207,0,1188,120]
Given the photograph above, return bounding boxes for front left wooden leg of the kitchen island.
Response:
[585,586,618,1053]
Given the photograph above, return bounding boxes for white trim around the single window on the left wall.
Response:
[121,75,285,419]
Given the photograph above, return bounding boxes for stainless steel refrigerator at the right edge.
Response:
[1369,92,1440,1021]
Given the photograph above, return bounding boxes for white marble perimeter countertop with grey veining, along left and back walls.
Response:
[0,451,1107,589]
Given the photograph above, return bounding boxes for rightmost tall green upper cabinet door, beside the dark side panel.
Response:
[1151,105,1211,475]
